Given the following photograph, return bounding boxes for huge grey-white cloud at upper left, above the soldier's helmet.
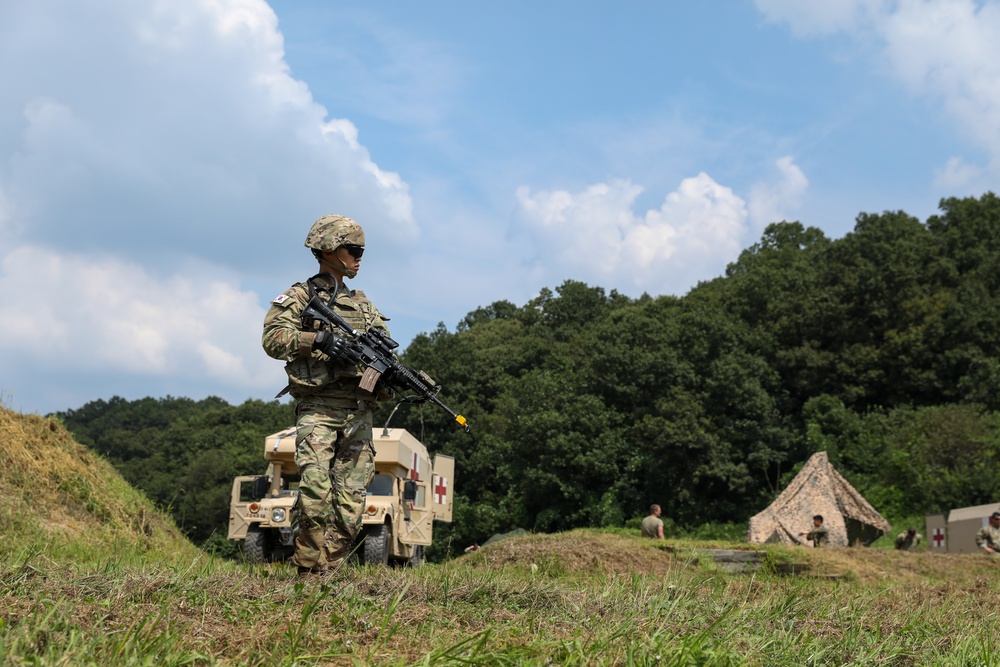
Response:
[0,0,418,266]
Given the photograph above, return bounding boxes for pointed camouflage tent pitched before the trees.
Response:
[747,452,892,547]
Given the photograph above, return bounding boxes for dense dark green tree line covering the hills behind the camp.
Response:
[57,193,1000,554]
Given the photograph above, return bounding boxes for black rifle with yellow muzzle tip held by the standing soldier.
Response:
[302,295,471,433]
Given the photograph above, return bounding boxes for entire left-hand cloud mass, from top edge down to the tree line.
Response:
[0,0,419,409]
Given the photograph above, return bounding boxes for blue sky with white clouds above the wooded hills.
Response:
[0,0,1000,414]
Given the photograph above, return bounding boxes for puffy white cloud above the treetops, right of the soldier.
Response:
[517,173,747,294]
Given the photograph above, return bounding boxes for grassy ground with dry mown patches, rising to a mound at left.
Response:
[0,409,1000,666]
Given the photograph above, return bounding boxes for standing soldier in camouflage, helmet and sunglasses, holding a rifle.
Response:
[262,215,389,575]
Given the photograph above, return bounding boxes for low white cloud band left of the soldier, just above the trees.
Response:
[0,246,281,395]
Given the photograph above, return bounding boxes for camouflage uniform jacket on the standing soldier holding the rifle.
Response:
[261,273,389,401]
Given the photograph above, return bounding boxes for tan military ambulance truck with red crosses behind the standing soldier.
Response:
[229,426,455,565]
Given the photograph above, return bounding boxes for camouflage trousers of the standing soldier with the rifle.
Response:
[292,398,375,570]
